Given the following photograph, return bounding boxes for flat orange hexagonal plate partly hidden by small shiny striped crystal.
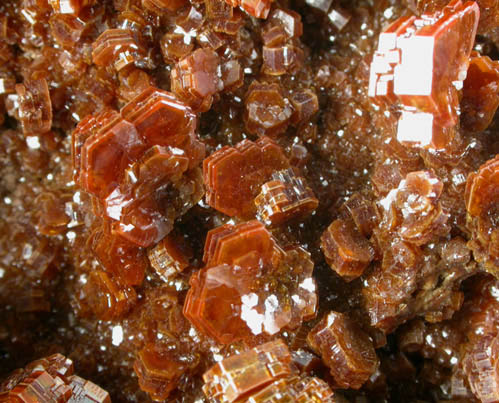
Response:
[203,137,289,217]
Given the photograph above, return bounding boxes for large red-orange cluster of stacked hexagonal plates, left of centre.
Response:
[72,87,204,247]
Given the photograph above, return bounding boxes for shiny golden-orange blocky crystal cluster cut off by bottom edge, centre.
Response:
[203,339,334,403]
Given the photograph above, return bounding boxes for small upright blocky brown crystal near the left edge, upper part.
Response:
[16,78,52,135]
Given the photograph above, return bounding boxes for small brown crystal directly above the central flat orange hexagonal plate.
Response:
[244,81,293,136]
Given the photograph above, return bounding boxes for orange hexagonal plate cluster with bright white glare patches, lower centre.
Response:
[184,221,317,344]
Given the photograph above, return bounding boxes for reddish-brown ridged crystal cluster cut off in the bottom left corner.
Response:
[0,354,111,403]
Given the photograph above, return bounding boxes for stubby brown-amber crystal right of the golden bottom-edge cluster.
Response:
[307,311,379,389]
